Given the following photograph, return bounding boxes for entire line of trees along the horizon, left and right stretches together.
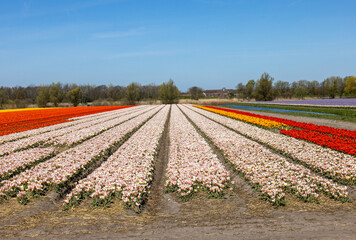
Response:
[0,73,356,108]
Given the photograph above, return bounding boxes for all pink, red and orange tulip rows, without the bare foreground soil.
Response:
[0,105,356,212]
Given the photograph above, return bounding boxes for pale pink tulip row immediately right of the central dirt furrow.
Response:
[166,105,230,199]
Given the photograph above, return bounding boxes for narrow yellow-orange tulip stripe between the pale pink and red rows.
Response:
[194,105,289,128]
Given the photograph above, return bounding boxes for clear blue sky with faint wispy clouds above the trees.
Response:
[0,0,356,91]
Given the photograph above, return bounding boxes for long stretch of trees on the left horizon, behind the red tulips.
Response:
[0,79,180,108]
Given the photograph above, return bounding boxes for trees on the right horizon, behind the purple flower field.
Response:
[236,73,356,101]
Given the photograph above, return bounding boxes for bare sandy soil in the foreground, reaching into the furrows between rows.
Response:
[0,109,356,239]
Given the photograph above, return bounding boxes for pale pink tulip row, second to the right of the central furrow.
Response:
[183,107,349,205]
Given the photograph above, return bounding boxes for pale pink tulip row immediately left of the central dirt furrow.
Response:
[64,106,169,212]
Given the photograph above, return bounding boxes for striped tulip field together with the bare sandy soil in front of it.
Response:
[0,104,356,238]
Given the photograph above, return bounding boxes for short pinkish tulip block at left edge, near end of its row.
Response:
[0,147,56,181]
